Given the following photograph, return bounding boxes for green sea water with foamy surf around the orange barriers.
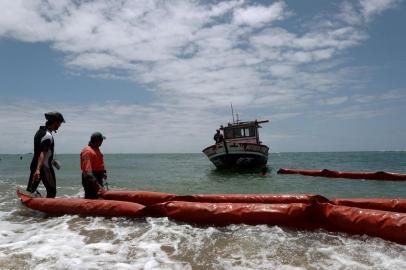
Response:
[0,152,406,270]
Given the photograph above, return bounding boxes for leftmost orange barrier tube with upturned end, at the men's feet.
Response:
[17,191,145,217]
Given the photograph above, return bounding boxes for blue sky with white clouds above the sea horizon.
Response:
[0,0,406,154]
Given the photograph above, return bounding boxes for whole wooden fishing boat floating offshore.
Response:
[202,116,269,169]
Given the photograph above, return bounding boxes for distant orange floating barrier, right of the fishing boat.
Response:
[278,168,406,181]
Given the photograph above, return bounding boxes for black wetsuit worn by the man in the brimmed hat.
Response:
[27,126,56,198]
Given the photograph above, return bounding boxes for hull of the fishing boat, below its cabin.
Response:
[203,143,269,169]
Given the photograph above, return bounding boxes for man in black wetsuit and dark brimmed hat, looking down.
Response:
[27,112,65,198]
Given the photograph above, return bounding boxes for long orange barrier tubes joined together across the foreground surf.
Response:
[17,191,406,244]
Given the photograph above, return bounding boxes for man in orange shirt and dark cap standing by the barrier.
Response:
[80,132,107,199]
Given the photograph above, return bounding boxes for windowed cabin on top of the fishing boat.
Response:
[220,120,269,144]
